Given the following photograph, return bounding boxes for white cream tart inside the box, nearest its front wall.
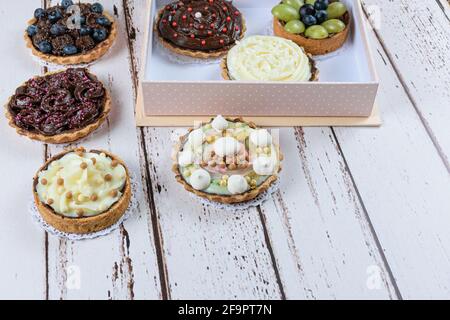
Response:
[222,36,317,82]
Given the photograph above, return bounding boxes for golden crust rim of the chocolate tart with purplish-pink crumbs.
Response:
[5,69,111,144]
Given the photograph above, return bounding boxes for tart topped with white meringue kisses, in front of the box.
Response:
[173,115,283,204]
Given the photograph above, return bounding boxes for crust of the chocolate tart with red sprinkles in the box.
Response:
[154,8,247,59]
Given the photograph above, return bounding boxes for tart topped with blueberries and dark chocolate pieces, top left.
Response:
[24,0,117,65]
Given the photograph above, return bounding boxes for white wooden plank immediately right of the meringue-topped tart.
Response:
[261,128,398,299]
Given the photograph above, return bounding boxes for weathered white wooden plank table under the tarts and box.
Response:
[0,0,450,299]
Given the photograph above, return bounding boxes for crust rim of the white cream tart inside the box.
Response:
[220,36,319,81]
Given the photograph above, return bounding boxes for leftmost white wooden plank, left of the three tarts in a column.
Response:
[0,1,46,299]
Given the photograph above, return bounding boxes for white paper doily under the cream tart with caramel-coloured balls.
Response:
[29,173,139,241]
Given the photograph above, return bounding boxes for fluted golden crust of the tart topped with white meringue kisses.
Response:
[172,117,283,204]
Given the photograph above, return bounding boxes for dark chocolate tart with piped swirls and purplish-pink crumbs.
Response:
[5,68,111,144]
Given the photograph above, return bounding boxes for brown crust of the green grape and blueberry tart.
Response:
[273,12,351,56]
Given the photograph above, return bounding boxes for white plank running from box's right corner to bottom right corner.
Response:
[334,9,450,299]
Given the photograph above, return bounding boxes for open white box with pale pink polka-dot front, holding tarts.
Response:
[136,0,380,126]
